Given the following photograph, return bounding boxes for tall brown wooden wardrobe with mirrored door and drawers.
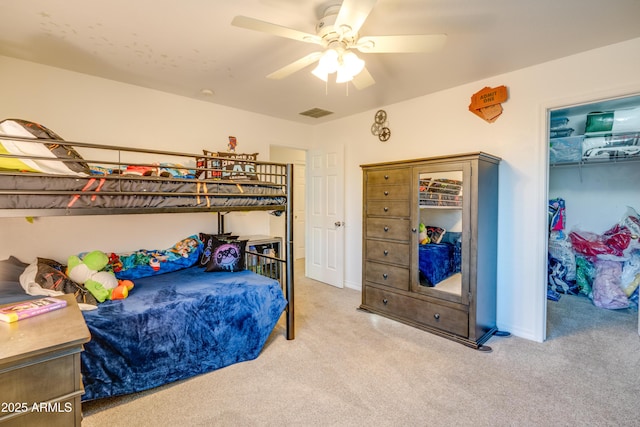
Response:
[360,152,500,350]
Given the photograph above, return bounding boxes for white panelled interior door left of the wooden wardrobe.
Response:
[305,145,344,288]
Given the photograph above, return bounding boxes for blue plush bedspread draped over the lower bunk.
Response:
[81,267,287,401]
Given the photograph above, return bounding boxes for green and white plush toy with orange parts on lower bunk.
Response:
[67,251,133,302]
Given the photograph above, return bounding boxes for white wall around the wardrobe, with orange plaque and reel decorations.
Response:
[314,39,640,341]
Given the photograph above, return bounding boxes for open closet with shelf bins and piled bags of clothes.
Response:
[546,94,640,340]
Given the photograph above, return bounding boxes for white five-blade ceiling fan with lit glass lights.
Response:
[231,0,446,89]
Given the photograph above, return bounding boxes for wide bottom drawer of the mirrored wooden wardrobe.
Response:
[364,286,469,337]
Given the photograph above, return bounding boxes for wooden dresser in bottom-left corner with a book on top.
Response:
[0,295,90,427]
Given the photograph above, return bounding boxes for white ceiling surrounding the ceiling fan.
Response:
[0,0,640,124]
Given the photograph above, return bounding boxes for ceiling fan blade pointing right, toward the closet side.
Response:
[356,34,447,53]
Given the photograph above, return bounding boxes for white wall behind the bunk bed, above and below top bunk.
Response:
[0,56,310,262]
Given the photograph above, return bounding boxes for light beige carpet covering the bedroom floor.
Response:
[83,262,640,427]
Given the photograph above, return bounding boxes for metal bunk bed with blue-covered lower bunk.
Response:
[0,125,294,401]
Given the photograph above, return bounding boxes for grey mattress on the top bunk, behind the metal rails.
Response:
[0,173,286,213]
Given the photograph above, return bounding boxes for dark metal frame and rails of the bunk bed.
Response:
[0,135,295,340]
